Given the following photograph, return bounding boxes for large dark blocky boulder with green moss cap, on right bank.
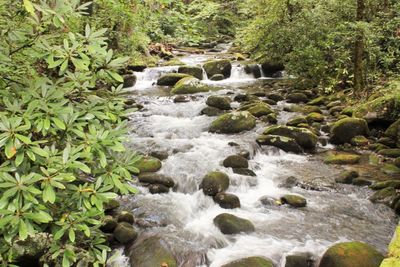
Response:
[330,118,369,145]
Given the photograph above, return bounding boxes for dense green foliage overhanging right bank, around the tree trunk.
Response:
[239,0,400,89]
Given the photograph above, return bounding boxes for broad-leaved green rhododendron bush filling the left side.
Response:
[0,0,138,266]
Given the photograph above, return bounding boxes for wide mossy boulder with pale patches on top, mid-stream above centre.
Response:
[209,111,256,134]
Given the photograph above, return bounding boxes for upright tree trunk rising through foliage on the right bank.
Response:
[353,0,365,93]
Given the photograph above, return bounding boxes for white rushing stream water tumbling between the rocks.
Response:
[118,50,396,267]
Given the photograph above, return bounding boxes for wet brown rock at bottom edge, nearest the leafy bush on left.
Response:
[129,236,178,267]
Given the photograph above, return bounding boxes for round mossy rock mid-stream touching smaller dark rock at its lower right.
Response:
[200,172,229,196]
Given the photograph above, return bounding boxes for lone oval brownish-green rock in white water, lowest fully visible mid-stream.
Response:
[214,213,255,235]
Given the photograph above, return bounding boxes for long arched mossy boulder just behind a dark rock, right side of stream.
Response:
[263,125,318,149]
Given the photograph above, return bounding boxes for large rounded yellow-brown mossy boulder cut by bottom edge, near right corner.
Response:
[319,242,384,267]
